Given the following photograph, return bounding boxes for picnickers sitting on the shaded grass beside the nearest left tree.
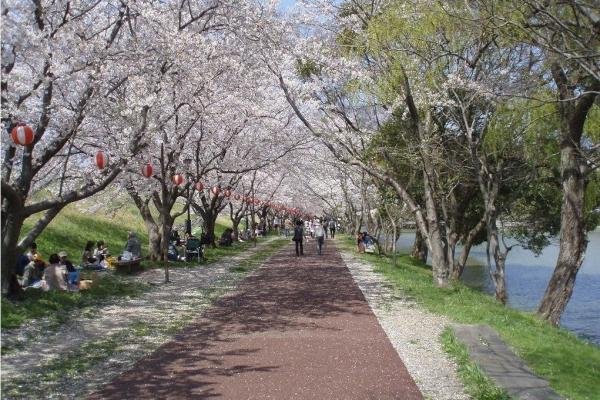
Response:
[17,232,141,291]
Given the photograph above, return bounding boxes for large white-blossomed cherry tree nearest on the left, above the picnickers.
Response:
[2,1,156,293]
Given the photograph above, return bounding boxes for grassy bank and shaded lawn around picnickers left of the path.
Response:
[1,199,236,328]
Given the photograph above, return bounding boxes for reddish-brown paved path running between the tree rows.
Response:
[92,241,422,400]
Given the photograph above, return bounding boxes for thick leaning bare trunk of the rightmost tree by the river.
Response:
[538,64,600,325]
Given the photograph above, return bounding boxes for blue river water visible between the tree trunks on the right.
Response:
[398,231,600,346]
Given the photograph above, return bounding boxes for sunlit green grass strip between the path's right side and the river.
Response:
[343,238,600,400]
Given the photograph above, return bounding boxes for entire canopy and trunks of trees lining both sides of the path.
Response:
[1,0,600,325]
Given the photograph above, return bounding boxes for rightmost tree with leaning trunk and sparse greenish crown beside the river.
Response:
[478,0,600,324]
